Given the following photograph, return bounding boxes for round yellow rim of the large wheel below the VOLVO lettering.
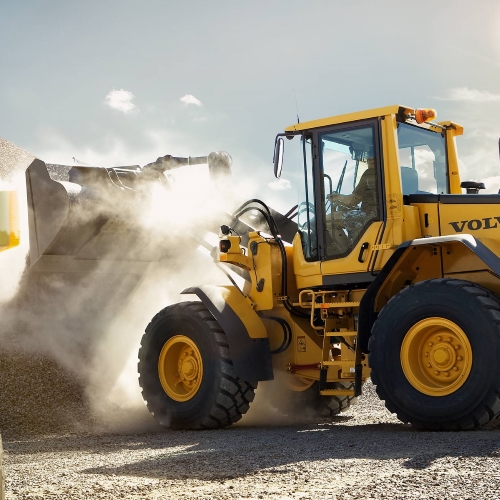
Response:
[400,318,472,396]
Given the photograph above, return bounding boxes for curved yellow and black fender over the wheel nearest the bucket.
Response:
[181,285,274,382]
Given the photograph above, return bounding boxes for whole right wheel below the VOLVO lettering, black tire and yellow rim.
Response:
[369,279,500,430]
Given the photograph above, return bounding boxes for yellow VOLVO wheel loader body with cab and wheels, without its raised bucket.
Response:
[138,105,500,430]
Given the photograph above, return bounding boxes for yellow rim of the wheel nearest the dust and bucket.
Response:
[158,335,203,402]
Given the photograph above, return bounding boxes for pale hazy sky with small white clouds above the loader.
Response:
[0,0,500,211]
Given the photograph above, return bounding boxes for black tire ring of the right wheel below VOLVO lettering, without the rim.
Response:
[370,281,499,422]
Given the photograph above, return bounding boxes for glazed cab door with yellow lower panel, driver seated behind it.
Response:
[275,119,385,285]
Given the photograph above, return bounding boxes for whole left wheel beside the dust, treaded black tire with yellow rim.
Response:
[138,302,257,429]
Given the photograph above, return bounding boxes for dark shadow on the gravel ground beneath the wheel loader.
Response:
[4,422,500,480]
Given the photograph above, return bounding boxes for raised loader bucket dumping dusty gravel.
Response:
[26,160,168,274]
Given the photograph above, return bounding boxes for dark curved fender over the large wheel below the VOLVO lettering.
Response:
[358,234,500,353]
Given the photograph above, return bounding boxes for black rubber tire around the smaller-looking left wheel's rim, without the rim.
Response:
[138,302,257,429]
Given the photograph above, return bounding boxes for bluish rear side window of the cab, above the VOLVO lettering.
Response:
[398,123,449,194]
